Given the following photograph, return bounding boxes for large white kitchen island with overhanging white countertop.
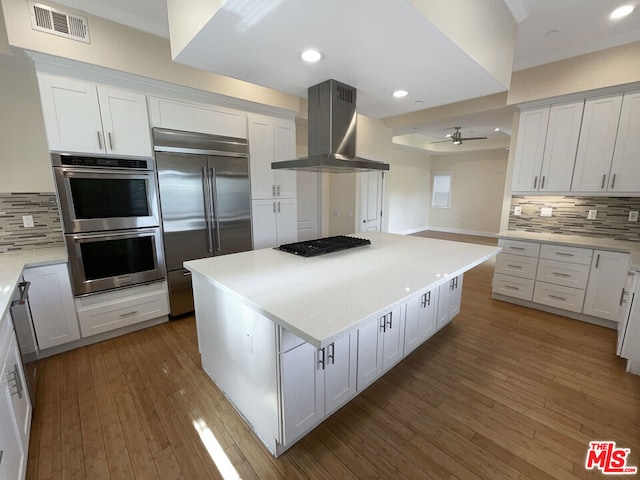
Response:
[185,232,500,456]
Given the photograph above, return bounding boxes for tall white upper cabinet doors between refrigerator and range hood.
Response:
[249,115,296,200]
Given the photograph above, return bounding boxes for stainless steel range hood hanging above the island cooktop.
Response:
[271,80,389,173]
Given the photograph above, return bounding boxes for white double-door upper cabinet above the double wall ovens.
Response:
[38,73,152,157]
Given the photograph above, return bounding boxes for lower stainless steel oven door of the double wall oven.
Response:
[65,228,164,295]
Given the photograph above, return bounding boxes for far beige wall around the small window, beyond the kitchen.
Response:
[428,150,508,234]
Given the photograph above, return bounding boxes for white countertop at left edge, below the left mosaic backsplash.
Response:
[0,247,67,322]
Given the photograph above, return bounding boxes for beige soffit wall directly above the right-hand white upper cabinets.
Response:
[507,42,640,105]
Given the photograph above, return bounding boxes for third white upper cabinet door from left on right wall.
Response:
[571,95,624,192]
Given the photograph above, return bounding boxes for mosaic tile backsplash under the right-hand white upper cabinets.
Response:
[509,196,640,242]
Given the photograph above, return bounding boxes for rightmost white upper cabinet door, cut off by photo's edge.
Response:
[609,91,640,192]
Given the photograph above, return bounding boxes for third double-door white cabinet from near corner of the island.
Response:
[404,288,439,355]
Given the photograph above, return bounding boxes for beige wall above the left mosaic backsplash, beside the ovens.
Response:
[0,52,55,193]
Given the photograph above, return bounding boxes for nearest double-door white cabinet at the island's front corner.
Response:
[280,334,357,445]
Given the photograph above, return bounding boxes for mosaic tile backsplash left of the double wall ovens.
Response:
[0,193,64,253]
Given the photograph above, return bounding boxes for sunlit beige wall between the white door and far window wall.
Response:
[385,147,431,233]
